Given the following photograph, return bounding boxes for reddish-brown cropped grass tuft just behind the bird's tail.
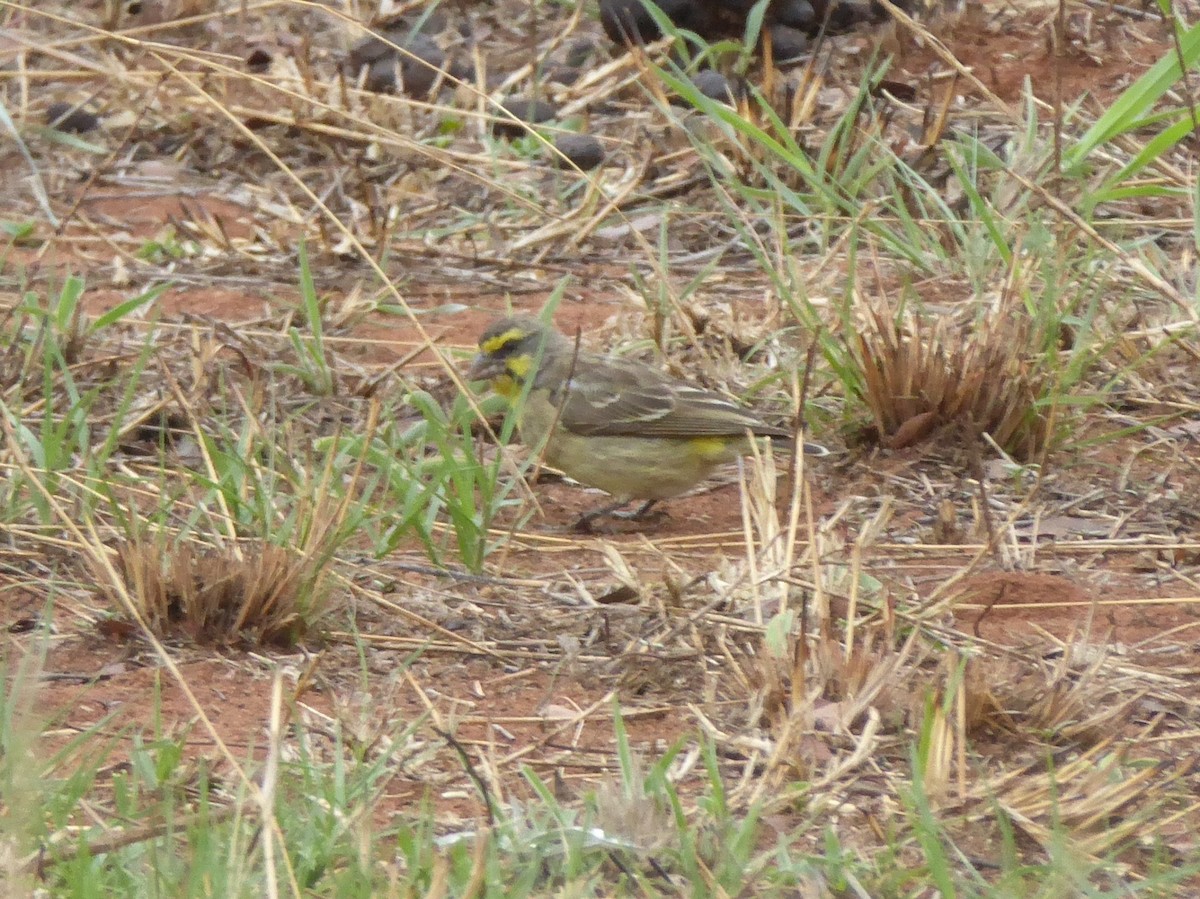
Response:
[853,301,1049,461]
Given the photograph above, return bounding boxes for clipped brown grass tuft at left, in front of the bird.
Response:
[100,540,324,646]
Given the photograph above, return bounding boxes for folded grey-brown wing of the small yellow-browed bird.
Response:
[554,360,791,437]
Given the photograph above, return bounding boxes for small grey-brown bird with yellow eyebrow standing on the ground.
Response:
[466,316,828,532]
